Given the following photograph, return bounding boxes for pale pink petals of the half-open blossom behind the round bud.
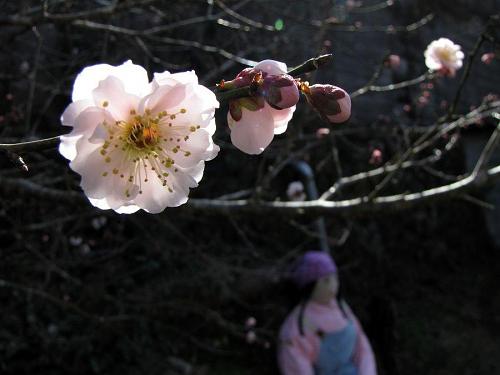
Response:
[227,60,296,155]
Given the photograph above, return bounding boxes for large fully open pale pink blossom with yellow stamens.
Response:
[59,61,219,213]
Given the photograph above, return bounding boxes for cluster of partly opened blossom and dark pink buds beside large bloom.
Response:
[219,60,351,154]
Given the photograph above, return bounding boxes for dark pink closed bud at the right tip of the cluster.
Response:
[303,85,351,124]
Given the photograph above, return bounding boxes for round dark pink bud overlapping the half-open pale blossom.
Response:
[260,74,300,109]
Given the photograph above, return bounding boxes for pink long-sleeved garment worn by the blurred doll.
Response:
[278,299,377,375]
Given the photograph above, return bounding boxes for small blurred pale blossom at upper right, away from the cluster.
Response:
[424,38,464,77]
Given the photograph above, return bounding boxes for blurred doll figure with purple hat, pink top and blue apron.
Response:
[278,251,377,375]
